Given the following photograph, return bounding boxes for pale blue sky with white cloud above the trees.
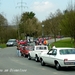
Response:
[0,0,74,24]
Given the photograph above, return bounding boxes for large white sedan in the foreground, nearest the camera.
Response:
[40,48,75,70]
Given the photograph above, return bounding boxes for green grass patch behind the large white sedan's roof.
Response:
[51,39,74,47]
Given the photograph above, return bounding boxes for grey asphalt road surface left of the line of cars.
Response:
[0,42,75,75]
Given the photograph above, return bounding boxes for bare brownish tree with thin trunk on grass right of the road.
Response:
[43,10,62,42]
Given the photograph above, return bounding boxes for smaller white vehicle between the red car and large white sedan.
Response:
[28,45,48,62]
